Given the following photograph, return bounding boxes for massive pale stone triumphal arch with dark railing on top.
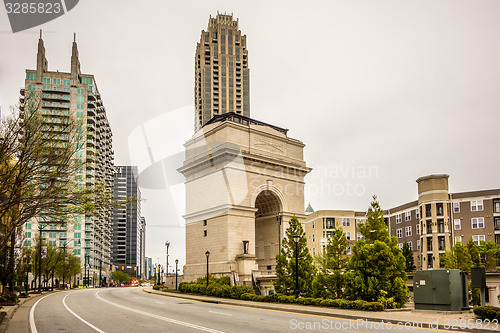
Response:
[178,113,311,285]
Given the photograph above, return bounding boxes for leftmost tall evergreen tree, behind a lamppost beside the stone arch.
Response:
[273,216,316,296]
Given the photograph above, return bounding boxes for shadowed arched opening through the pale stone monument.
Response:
[255,190,282,270]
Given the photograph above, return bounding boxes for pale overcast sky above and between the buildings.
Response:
[0,0,500,272]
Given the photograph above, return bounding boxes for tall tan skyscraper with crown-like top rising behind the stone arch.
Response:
[194,14,250,131]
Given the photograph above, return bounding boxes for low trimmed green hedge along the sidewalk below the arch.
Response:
[154,283,384,311]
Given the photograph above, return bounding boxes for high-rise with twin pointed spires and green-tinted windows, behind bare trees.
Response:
[21,33,114,285]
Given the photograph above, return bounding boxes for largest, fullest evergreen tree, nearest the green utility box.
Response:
[344,196,408,308]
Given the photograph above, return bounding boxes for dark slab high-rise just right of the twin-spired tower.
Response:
[111,166,146,277]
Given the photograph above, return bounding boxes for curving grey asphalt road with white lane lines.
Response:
[7,288,456,333]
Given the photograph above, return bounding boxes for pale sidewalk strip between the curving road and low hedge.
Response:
[143,288,498,332]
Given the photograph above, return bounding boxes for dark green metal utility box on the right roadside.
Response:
[413,269,469,311]
